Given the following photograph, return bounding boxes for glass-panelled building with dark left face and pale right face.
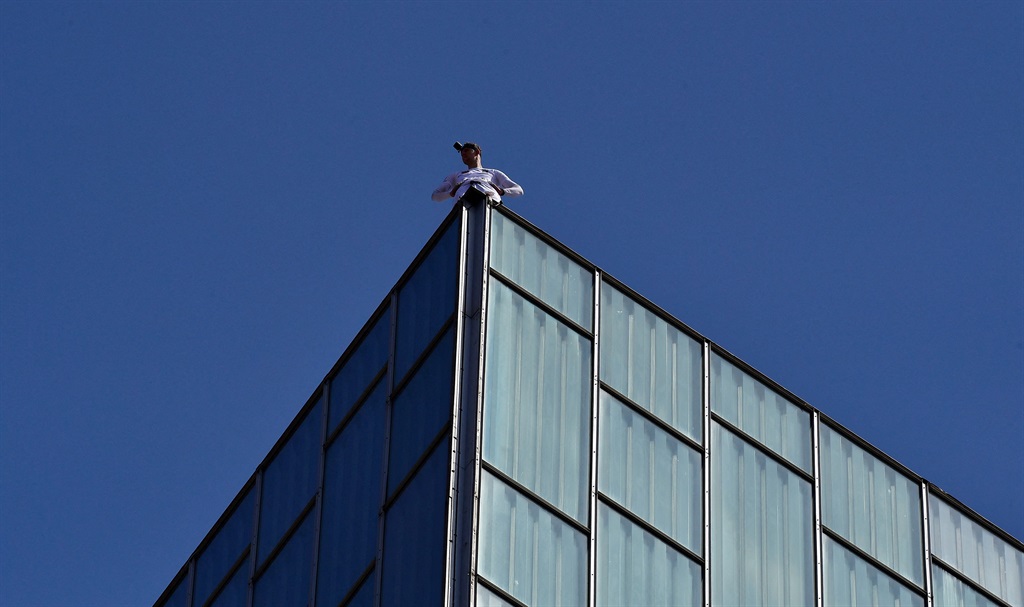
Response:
[156,205,1024,607]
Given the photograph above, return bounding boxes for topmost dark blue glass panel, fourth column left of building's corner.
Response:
[193,488,256,605]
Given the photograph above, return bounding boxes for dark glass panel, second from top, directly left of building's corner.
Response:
[387,329,455,494]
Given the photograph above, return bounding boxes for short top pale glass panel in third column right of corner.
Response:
[711,355,811,472]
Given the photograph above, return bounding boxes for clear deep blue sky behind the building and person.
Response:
[0,0,1024,606]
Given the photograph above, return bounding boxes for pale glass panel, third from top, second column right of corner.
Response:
[597,505,703,607]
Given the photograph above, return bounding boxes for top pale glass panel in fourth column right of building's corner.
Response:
[820,424,925,587]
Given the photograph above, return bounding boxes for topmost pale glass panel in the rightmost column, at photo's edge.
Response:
[928,495,1024,607]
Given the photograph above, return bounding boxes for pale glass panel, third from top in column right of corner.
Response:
[478,471,587,607]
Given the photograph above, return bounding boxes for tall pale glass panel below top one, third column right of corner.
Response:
[711,423,814,607]
